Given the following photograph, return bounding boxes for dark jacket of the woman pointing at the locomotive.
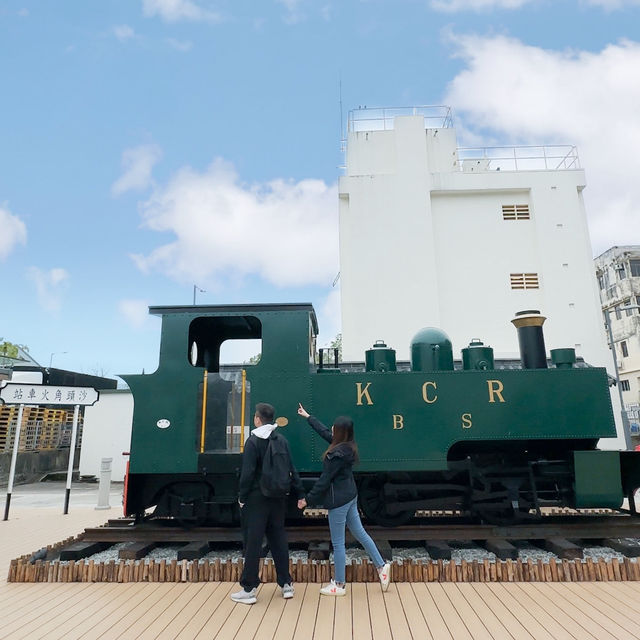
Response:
[307,416,358,509]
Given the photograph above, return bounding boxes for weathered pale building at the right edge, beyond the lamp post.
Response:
[594,246,640,433]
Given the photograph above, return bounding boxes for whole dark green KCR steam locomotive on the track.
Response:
[123,304,640,526]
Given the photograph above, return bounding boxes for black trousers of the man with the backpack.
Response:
[240,492,292,591]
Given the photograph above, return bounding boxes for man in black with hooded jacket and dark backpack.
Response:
[231,402,304,604]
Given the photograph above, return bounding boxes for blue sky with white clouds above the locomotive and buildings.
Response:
[0,0,640,375]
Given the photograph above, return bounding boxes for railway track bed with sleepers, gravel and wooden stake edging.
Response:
[9,512,640,582]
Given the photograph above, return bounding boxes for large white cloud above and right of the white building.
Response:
[445,36,640,253]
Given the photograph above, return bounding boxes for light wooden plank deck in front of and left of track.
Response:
[0,509,640,640]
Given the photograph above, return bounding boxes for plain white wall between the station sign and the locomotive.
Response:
[80,389,133,481]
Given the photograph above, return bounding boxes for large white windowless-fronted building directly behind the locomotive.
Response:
[340,107,623,446]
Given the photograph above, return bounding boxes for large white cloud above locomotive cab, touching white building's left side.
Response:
[133,159,338,289]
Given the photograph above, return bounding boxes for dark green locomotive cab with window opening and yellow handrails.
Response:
[123,304,317,523]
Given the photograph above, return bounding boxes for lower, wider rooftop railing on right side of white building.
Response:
[457,144,580,172]
